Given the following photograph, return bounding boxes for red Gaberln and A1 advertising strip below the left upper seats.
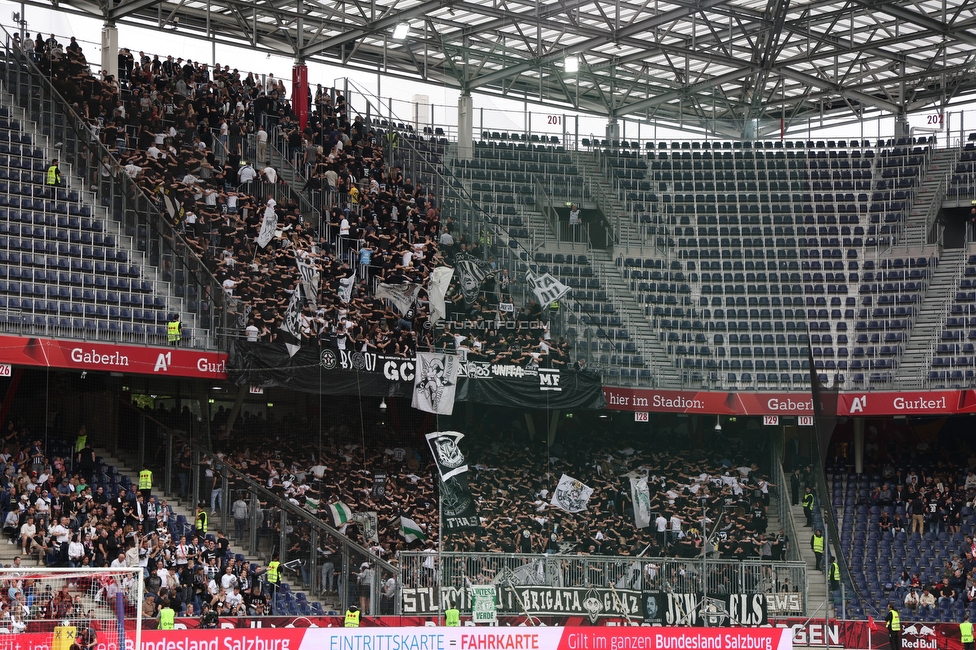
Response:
[0,336,227,379]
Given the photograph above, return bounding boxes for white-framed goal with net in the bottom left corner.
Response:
[0,566,143,650]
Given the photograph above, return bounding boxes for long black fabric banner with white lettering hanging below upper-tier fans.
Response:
[227,341,606,409]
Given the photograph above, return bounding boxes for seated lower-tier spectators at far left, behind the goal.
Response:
[0,412,286,628]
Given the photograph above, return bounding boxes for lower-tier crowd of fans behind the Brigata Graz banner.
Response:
[143,400,776,562]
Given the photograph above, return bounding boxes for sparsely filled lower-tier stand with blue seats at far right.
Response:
[827,433,976,622]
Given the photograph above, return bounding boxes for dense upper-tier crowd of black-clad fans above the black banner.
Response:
[25,36,568,367]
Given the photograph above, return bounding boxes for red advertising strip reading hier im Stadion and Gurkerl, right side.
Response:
[603,386,976,421]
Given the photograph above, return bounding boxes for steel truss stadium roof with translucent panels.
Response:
[34,0,976,137]
